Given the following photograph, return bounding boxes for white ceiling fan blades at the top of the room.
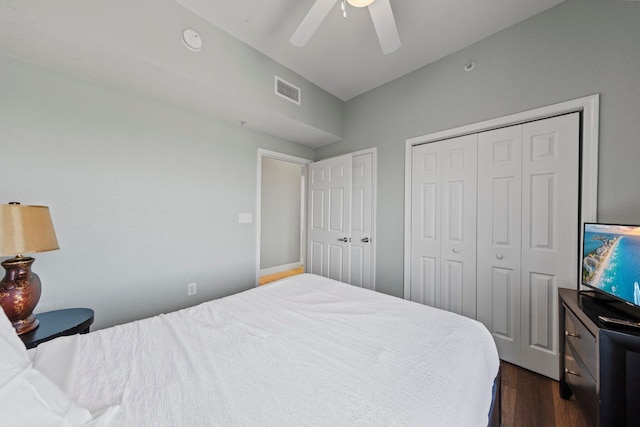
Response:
[289,0,401,55]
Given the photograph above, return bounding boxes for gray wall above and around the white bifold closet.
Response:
[317,0,640,296]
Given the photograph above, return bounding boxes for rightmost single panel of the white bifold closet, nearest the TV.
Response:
[522,113,580,380]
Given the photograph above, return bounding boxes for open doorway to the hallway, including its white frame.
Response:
[256,149,311,285]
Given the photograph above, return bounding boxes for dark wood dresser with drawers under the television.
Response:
[558,289,640,427]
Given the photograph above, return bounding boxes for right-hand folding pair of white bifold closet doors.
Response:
[478,113,580,380]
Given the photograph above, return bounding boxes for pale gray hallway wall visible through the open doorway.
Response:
[260,157,302,269]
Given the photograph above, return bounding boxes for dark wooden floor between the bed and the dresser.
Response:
[501,362,589,427]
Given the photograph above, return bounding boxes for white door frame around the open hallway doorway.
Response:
[255,148,312,286]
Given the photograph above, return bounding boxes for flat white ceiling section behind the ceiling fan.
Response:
[175,0,564,101]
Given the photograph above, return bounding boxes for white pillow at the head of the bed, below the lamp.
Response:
[0,309,117,427]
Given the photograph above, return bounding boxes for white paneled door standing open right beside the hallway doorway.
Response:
[307,154,352,283]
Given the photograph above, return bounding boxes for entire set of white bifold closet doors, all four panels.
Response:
[409,113,580,379]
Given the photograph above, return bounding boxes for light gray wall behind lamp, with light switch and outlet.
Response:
[0,56,314,328]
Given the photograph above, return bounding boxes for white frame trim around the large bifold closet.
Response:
[404,94,600,299]
